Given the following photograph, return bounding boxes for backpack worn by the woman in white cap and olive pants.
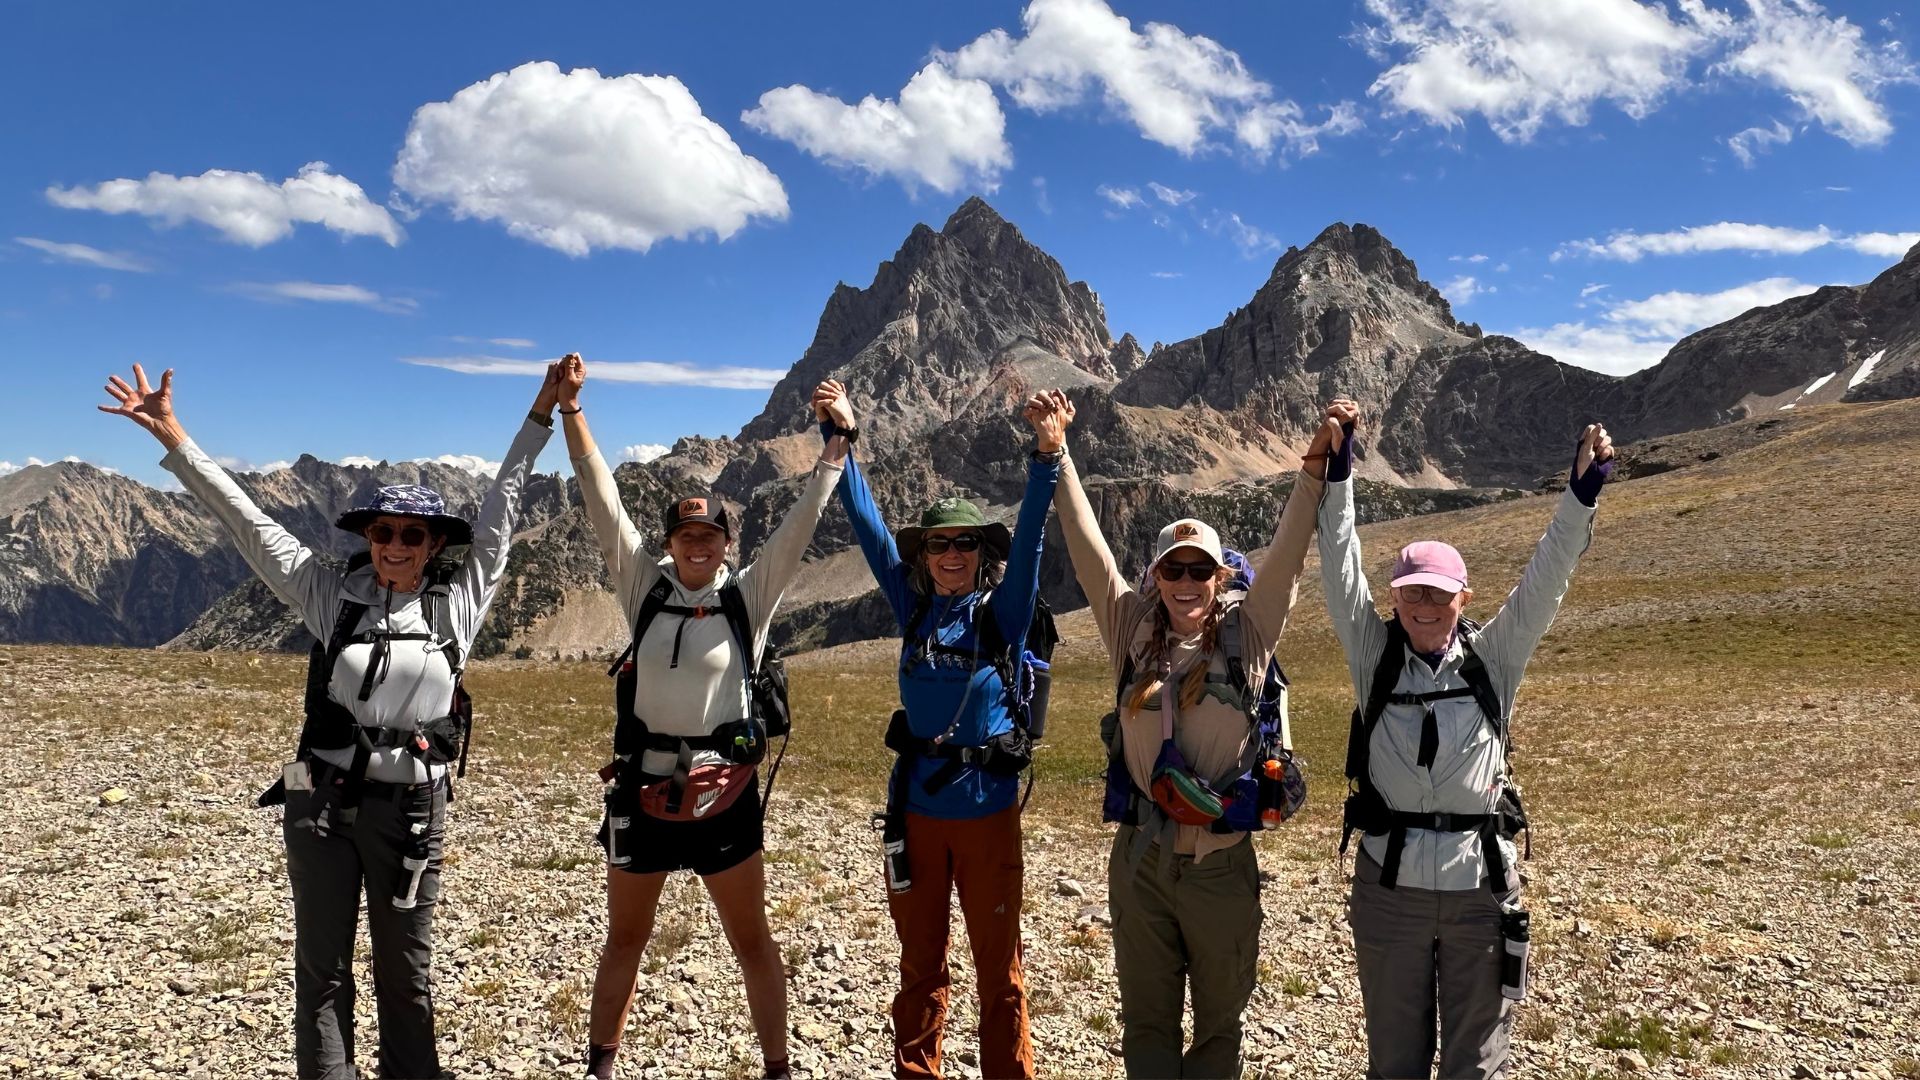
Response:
[1100,548,1306,834]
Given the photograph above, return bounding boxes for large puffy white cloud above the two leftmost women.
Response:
[394,61,787,256]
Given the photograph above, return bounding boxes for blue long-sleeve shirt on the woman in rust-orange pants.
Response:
[839,447,1060,819]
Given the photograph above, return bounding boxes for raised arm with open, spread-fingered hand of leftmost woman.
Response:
[100,363,340,640]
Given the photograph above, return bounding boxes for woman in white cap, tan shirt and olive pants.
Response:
[1029,390,1331,1076]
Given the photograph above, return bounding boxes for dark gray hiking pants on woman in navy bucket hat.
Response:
[280,780,447,1080]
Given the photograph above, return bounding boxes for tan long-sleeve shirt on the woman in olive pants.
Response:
[1054,461,1323,863]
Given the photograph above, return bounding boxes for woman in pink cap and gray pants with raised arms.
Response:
[1319,404,1613,1080]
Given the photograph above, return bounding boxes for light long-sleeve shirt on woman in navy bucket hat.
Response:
[159,419,553,784]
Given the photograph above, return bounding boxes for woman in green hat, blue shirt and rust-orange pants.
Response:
[814,374,1062,1078]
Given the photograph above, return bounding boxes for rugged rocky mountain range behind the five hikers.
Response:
[0,198,1920,655]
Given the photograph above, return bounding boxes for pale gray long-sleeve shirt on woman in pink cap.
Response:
[1319,479,1594,890]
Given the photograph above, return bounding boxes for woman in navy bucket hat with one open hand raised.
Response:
[100,363,559,1080]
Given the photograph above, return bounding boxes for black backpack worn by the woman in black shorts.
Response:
[603,575,793,813]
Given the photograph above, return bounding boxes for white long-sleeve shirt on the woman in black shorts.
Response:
[572,450,841,776]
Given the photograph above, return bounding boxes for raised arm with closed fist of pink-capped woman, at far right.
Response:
[1478,425,1613,687]
